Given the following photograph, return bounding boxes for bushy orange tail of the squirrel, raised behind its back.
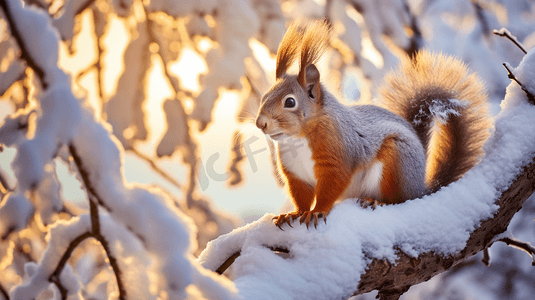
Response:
[379,51,490,191]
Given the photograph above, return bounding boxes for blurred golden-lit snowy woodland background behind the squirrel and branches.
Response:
[0,0,535,299]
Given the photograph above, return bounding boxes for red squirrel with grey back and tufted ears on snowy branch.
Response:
[256,20,490,229]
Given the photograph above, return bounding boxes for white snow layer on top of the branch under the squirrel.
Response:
[199,51,535,299]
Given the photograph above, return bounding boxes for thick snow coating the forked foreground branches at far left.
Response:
[0,0,236,299]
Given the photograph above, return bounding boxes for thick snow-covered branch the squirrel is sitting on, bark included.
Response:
[199,51,535,299]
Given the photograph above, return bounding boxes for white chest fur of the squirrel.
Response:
[277,137,317,186]
